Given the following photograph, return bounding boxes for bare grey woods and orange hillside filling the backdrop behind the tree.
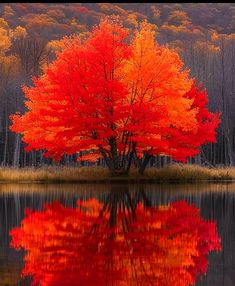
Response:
[0,3,235,167]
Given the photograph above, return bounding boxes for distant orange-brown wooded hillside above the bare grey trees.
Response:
[0,3,235,40]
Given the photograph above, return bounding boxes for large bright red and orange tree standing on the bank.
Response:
[11,18,219,174]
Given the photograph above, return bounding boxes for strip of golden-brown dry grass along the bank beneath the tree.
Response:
[0,164,235,183]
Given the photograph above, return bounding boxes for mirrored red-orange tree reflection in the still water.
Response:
[10,190,221,286]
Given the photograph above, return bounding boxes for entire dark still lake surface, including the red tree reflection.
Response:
[0,184,235,286]
